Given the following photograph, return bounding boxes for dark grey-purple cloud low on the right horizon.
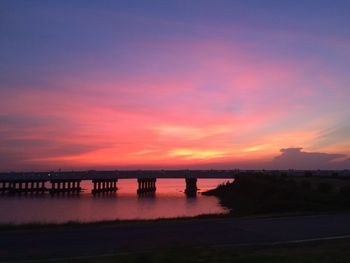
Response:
[272,148,350,169]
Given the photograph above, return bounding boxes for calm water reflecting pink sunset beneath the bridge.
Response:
[0,179,232,224]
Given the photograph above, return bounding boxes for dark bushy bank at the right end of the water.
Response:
[203,175,350,216]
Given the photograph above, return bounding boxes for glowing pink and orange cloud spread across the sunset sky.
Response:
[0,39,348,171]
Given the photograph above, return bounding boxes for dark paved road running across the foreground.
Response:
[0,214,350,261]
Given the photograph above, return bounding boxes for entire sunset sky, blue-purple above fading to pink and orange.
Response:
[0,0,350,171]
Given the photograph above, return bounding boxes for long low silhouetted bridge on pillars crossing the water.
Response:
[0,169,350,195]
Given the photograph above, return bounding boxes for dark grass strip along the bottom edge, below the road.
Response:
[66,239,350,263]
